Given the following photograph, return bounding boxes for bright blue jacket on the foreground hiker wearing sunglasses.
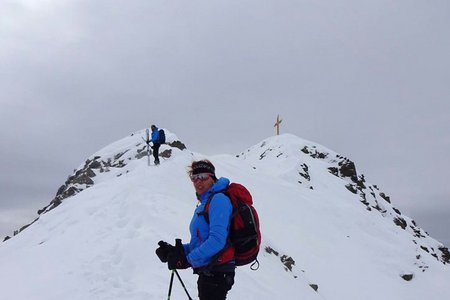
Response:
[184,177,233,268]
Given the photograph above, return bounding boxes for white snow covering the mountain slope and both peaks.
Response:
[0,129,450,300]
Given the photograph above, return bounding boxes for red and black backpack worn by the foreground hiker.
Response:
[200,183,261,269]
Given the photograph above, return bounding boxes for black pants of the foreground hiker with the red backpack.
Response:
[197,272,234,300]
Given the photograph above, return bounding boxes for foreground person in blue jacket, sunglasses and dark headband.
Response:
[156,160,236,300]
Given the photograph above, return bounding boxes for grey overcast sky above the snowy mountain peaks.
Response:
[0,0,450,246]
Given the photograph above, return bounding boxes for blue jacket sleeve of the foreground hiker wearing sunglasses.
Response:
[185,193,233,267]
